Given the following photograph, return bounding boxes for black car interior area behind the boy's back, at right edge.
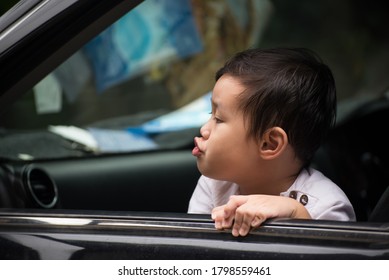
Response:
[313,91,389,222]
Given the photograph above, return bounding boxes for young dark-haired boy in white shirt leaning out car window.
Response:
[188,48,355,236]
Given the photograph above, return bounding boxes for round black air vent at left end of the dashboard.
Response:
[25,167,58,208]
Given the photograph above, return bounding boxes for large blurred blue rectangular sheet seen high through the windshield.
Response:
[84,0,203,92]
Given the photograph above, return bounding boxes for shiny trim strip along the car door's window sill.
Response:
[0,213,389,244]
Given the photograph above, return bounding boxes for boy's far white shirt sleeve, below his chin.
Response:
[188,176,214,214]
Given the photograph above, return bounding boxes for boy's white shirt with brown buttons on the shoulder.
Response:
[188,168,356,221]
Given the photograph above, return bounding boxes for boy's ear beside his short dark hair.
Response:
[259,127,288,159]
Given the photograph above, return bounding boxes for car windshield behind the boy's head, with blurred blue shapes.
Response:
[0,0,389,160]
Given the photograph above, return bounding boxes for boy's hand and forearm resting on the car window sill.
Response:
[212,195,311,236]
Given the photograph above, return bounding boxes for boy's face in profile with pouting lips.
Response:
[192,75,259,182]
